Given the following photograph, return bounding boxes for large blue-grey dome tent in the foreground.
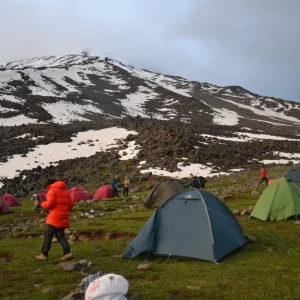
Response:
[123,189,247,262]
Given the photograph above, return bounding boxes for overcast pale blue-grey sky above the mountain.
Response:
[0,0,300,101]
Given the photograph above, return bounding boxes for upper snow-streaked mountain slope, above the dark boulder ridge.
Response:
[0,55,300,129]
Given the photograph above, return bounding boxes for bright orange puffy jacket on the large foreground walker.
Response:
[41,181,74,228]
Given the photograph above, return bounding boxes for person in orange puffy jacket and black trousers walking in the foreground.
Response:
[34,179,74,260]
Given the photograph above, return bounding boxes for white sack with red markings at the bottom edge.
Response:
[85,274,129,300]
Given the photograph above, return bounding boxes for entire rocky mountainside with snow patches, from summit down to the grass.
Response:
[0,55,300,194]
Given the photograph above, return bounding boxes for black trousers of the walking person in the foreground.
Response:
[41,224,70,257]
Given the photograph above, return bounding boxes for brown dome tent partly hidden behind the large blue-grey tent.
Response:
[143,179,185,208]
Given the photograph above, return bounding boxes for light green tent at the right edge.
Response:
[250,178,300,221]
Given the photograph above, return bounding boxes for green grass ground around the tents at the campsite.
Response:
[0,170,300,300]
